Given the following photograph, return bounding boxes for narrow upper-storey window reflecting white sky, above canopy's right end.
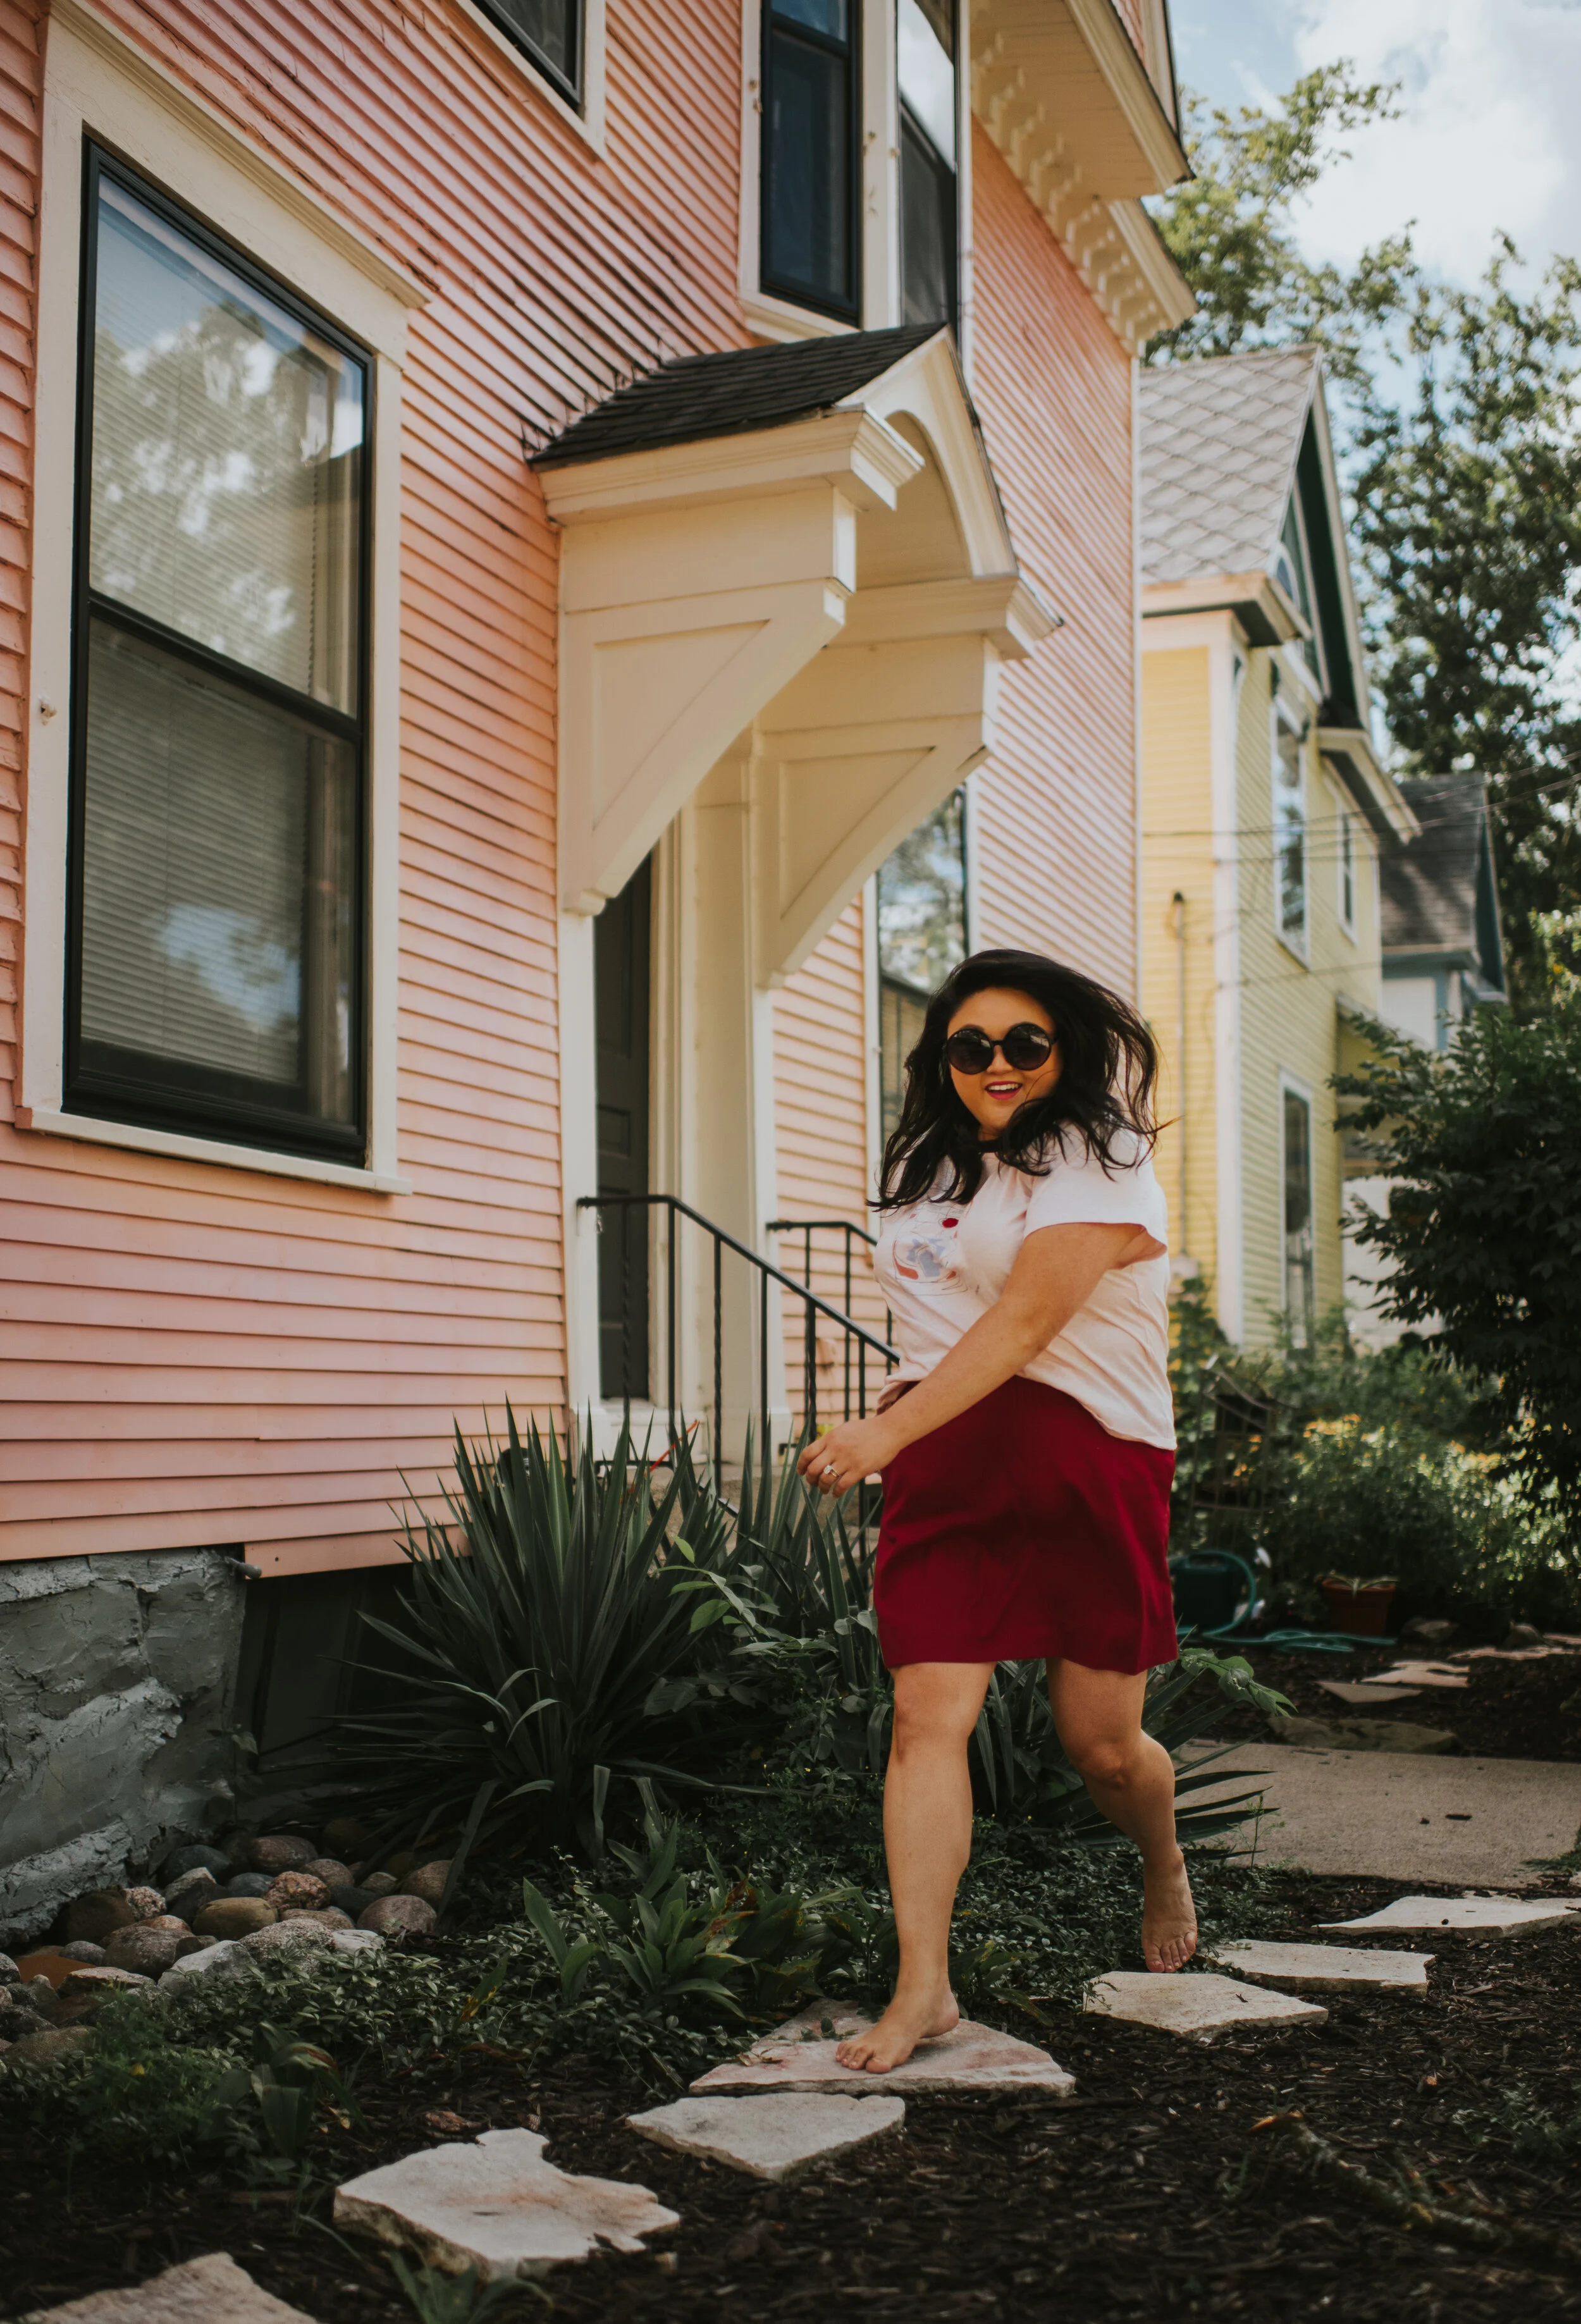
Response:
[895,0,960,323]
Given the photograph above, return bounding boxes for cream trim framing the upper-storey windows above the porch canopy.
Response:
[737,0,972,343]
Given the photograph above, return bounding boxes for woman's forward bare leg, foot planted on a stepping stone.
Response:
[835,1662,993,2073]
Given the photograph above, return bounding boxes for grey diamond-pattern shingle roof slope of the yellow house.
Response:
[1141,347,1319,581]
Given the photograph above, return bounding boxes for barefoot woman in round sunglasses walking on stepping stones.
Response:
[802,950,1197,2073]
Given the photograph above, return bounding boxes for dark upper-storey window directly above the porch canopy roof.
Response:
[758,0,863,323]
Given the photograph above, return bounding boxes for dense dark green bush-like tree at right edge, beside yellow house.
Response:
[1334,990,1581,1529]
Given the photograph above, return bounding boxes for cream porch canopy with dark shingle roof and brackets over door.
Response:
[535,326,1055,1406]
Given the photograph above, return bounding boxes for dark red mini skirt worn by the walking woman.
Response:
[874,1376,1176,1673]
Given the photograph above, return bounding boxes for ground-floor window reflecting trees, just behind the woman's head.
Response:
[879,790,967,1139]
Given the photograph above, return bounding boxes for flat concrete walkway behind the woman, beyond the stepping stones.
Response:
[1216,1743,1581,1887]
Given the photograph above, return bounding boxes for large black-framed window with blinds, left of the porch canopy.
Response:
[65,147,372,1162]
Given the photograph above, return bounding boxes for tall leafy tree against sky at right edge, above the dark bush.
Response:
[1351,254,1581,1011]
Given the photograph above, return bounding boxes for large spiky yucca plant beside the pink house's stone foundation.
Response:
[340,1408,767,1855]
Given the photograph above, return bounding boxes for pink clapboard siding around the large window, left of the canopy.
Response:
[0,0,744,1566]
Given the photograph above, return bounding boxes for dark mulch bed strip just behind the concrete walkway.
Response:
[1218,1641,1581,1762]
